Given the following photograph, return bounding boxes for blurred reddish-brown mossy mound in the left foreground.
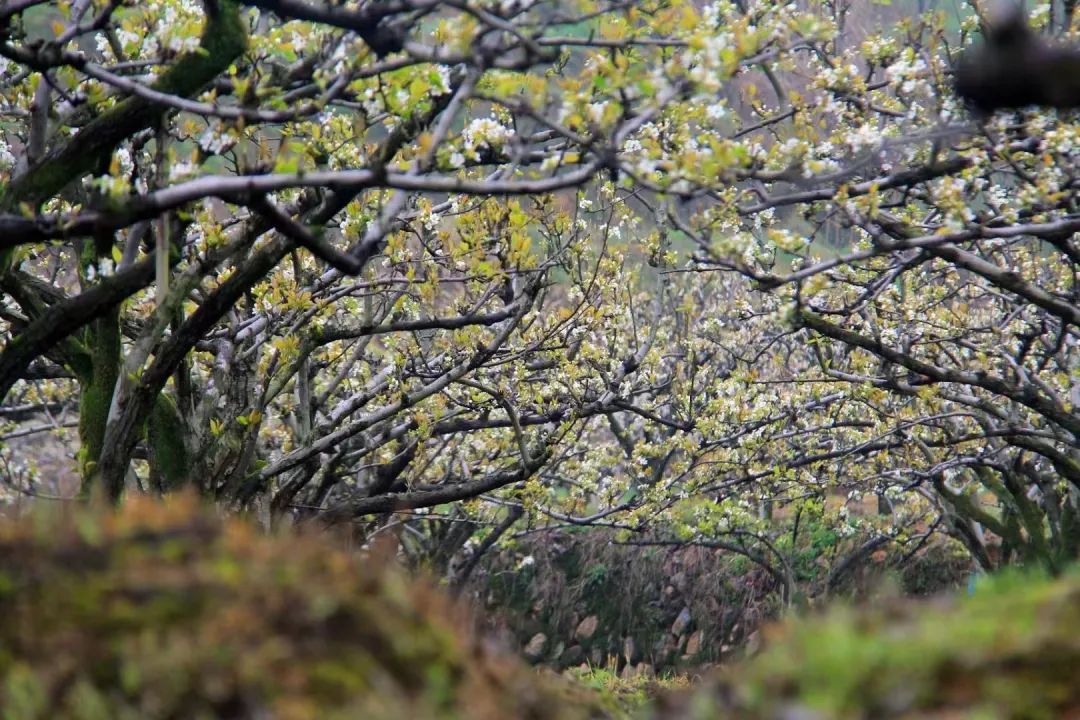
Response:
[0,499,604,720]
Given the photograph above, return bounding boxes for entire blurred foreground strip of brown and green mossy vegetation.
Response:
[0,499,1080,720]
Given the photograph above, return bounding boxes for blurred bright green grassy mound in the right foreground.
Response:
[654,572,1080,720]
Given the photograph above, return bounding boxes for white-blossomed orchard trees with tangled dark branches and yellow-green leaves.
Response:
[0,0,1080,602]
